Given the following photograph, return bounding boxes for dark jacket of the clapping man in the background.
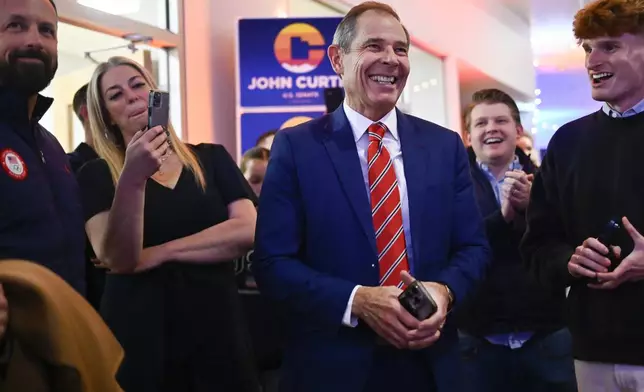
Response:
[456,148,566,338]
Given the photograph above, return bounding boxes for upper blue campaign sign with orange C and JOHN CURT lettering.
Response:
[238,18,342,107]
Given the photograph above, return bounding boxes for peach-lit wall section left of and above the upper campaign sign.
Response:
[182,0,288,153]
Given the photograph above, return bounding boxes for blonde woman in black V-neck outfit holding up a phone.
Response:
[78,57,257,392]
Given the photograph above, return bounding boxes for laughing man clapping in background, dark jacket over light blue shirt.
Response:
[456,89,577,392]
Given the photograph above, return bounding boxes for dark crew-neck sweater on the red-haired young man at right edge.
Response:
[521,110,644,366]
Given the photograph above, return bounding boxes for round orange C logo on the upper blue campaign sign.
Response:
[274,23,326,74]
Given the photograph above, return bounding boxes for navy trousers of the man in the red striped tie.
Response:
[364,346,436,392]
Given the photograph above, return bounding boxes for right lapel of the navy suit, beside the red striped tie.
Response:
[397,111,429,271]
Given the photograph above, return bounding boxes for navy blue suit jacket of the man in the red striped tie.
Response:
[253,106,489,392]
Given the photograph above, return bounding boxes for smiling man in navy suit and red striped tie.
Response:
[253,2,489,392]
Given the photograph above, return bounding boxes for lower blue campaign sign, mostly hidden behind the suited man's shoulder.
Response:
[241,112,324,154]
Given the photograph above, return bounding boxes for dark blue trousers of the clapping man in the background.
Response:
[459,329,577,392]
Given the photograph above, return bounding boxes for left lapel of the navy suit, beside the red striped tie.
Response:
[324,105,377,254]
